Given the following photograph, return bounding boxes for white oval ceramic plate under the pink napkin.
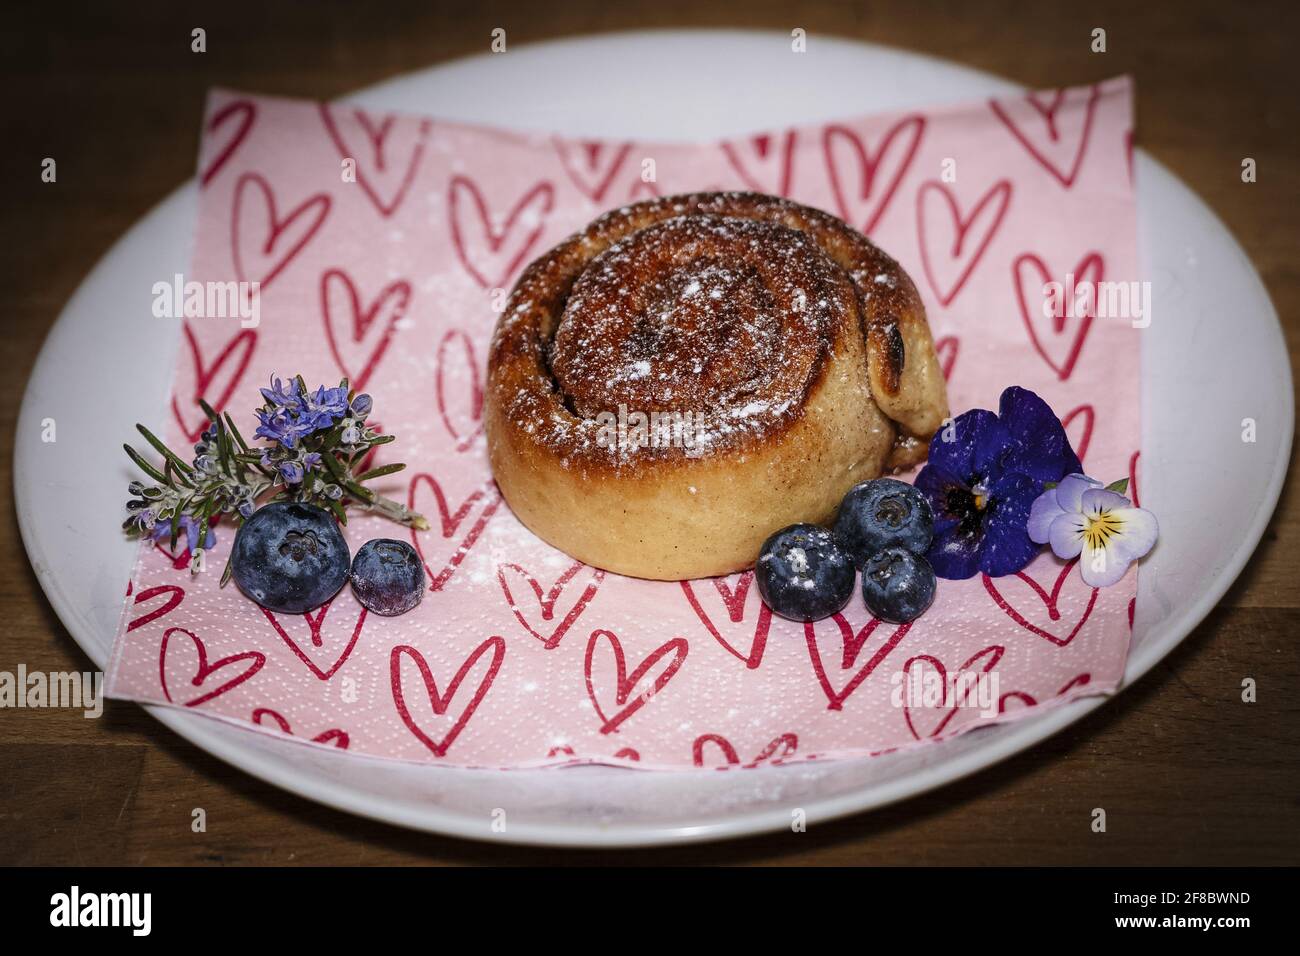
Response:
[14,31,1294,845]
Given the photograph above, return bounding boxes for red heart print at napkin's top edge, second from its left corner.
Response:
[321,103,433,219]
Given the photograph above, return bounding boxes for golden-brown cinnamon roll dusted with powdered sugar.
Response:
[484,193,948,580]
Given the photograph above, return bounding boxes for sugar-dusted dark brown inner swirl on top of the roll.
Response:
[530,215,855,458]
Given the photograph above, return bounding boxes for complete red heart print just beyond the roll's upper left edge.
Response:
[447,176,555,289]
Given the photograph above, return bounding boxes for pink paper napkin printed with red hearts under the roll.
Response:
[109,78,1139,769]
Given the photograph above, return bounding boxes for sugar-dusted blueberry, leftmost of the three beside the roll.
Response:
[754,524,857,620]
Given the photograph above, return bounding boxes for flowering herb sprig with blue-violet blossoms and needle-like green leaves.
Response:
[122,376,429,584]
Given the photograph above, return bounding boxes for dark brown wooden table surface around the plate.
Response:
[0,0,1300,865]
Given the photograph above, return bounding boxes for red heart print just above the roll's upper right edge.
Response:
[822,116,926,235]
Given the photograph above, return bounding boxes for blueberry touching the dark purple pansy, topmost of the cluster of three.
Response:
[835,479,935,568]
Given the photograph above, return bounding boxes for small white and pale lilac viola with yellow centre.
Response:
[1027,473,1160,588]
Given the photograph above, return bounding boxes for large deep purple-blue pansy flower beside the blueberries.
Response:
[915,386,1082,579]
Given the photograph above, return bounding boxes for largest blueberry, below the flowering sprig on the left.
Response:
[230,501,352,614]
